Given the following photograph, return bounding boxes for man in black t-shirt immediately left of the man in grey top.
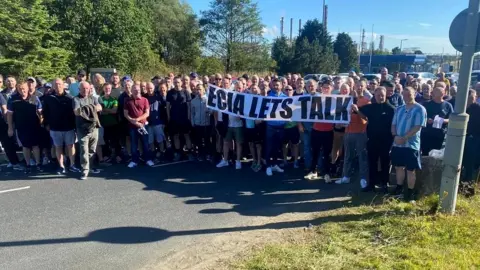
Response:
[167,76,193,161]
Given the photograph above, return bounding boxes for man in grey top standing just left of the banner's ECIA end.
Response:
[191,84,212,161]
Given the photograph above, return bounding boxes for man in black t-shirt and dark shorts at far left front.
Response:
[7,83,43,173]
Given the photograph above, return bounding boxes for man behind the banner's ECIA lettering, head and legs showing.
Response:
[217,80,244,170]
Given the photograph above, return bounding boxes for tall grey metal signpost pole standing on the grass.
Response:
[440,0,480,214]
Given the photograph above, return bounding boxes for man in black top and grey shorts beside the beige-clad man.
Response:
[43,79,80,174]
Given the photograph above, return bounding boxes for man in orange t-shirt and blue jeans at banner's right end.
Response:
[335,79,370,188]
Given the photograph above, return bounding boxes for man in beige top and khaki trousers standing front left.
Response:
[73,81,102,180]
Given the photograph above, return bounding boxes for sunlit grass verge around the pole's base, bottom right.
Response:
[232,196,480,269]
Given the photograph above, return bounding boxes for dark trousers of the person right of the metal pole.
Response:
[463,135,480,182]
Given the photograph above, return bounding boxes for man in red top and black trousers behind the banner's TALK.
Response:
[305,80,333,183]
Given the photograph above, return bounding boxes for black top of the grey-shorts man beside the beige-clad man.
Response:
[42,93,75,131]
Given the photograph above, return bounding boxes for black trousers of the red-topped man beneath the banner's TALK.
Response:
[310,129,333,174]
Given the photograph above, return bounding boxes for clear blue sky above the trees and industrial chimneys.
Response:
[185,0,468,54]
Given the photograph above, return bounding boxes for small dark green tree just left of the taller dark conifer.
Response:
[272,36,295,74]
